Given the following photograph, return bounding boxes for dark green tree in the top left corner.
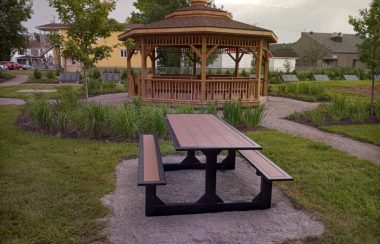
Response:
[0,0,32,60]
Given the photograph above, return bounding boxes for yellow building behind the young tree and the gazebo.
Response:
[36,23,151,72]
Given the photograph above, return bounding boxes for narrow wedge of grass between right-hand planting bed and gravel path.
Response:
[321,124,380,146]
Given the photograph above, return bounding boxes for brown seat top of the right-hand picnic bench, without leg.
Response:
[239,150,293,181]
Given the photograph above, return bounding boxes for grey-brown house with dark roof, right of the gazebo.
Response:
[293,32,366,67]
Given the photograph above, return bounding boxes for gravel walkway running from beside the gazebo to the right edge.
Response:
[263,97,380,164]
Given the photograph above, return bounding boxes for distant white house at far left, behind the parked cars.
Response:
[11,35,54,69]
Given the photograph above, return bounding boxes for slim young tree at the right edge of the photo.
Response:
[349,0,380,115]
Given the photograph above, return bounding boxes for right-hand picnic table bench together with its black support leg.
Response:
[239,150,293,208]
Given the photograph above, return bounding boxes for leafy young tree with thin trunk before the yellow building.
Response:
[49,0,122,98]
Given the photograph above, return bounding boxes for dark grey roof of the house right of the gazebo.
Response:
[302,32,362,53]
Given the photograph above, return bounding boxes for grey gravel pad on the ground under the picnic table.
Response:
[103,156,324,244]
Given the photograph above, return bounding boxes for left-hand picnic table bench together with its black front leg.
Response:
[138,135,166,216]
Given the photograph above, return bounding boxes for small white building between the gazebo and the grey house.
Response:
[269,50,298,72]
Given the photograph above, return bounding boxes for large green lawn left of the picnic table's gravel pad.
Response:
[0,106,172,243]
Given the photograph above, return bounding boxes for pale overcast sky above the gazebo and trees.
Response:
[25,0,371,43]
